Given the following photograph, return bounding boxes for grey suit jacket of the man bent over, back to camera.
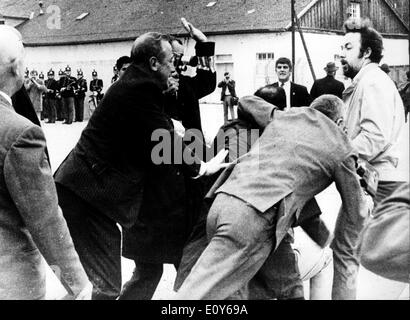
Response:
[216,96,367,250]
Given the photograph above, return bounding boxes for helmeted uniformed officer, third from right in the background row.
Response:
[60,65,77,124]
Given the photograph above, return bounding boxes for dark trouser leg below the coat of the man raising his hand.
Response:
[119,260,178,300]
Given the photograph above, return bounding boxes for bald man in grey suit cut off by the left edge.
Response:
[0,26,92,300]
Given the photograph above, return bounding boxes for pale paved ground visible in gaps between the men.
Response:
[42,104,409,300]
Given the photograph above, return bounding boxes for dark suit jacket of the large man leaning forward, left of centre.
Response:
[55,64,200,238]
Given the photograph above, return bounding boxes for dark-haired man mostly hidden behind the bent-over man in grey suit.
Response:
[174,85,331,300]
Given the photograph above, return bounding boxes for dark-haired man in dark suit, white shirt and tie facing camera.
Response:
[273,57,312,110]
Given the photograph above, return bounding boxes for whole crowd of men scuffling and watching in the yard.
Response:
[0,18,410,300]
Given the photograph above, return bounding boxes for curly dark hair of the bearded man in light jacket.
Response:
[343,18,384,63]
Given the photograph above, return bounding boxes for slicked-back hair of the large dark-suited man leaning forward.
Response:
[131,32,169,64]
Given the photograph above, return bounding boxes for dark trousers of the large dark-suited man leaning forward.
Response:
[56,183,121,300]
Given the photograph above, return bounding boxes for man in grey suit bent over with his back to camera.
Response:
[173,96,368,300]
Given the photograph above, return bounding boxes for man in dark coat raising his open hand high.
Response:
[120,18,216,300]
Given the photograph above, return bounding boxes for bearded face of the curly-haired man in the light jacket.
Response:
[340,32,365,79]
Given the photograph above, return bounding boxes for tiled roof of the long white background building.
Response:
[4,0,312,45]
